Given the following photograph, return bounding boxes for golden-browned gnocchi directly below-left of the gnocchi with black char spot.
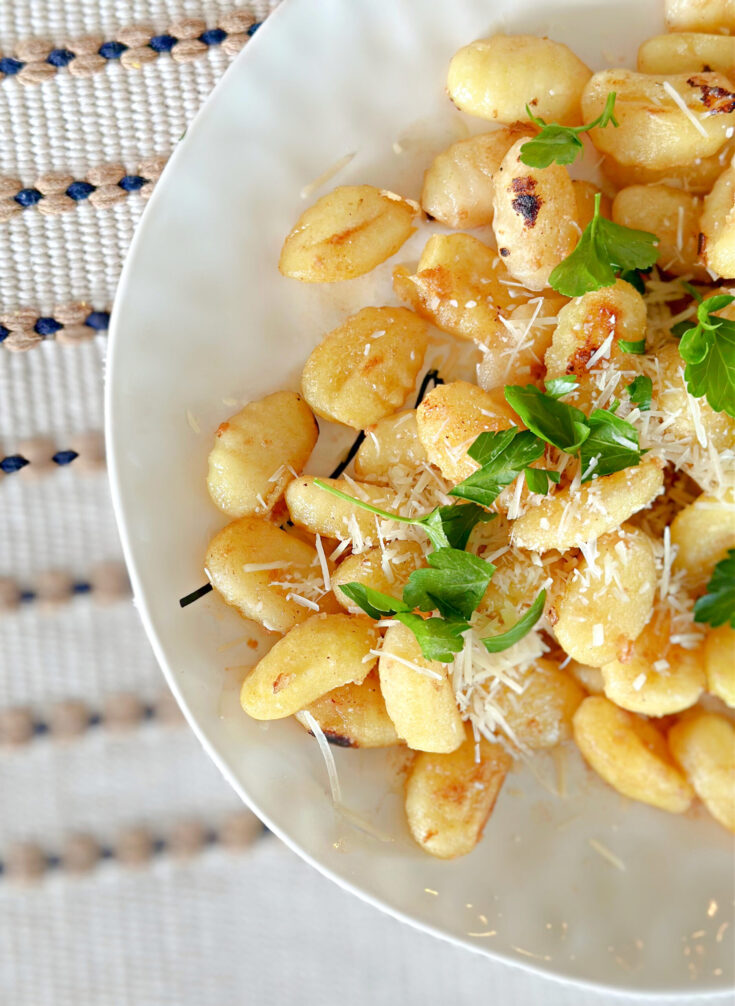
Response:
[393,234,518,342]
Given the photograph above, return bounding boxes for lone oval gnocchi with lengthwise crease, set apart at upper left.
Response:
[279,185,419,283]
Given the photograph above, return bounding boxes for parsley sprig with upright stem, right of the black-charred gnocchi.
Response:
[549,193,659,297]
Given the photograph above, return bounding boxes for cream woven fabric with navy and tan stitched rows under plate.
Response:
[0,0,699,1006]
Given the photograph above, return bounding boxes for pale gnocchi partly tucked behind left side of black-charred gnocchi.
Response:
[421,123,535,227]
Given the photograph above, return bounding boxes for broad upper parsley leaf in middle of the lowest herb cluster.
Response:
[403,548,495,619]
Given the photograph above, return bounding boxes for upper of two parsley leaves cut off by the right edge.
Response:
[679,294,735,418]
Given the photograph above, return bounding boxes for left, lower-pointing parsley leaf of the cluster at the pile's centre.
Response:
[449,428,544,506]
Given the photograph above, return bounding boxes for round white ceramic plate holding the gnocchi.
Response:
[108,0,733,996]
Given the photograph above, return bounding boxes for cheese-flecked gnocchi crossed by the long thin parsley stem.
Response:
[286,476,395,551]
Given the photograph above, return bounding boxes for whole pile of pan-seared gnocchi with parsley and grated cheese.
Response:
[205,0,735,858]
